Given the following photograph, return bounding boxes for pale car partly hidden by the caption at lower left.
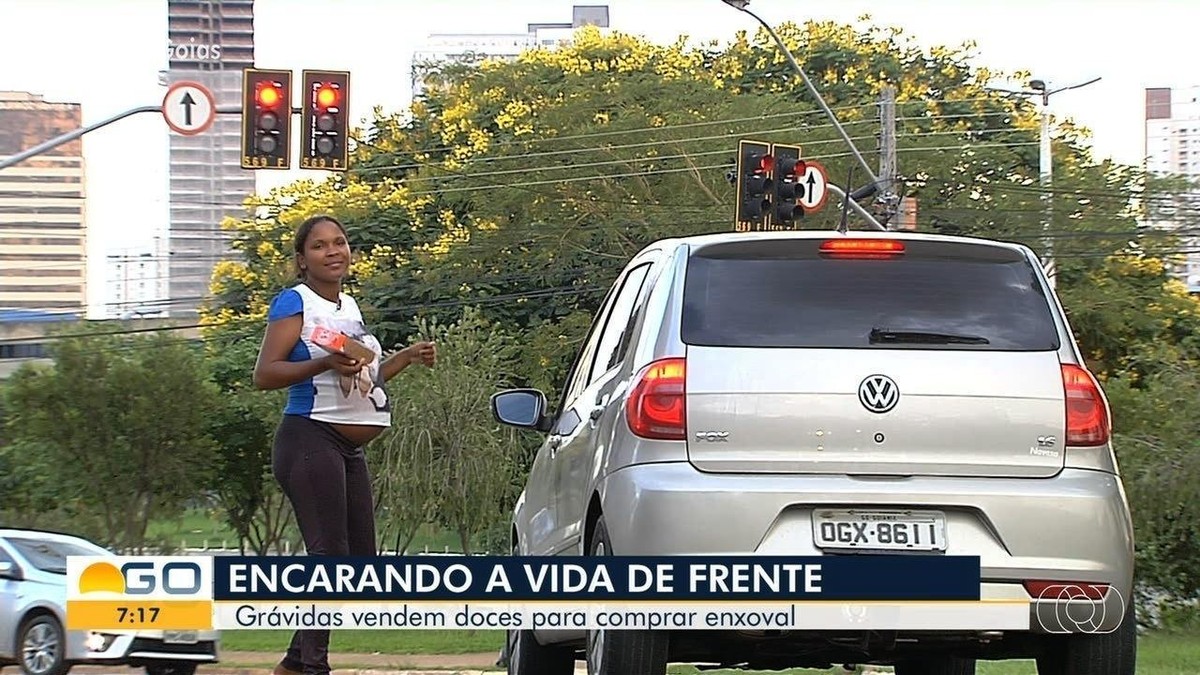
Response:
[0,528,220,675]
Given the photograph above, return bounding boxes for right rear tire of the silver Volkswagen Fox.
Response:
[1038,595,1138,675]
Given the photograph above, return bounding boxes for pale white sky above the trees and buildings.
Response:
[0,0,1200,314]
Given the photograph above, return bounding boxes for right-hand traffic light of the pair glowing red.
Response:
[300,71,350,171]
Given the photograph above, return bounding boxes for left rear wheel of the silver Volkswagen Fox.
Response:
[587,516,671,675]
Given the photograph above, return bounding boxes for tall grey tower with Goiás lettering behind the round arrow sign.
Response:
[161,0,256,316]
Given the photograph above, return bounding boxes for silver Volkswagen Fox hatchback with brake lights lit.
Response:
[492,231,1136,675]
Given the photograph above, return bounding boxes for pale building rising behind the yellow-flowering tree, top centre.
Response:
[412,5,608,98]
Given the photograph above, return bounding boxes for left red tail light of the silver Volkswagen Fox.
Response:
[625,358,688,441]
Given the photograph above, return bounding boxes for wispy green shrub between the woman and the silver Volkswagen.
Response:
[376,310,523,552]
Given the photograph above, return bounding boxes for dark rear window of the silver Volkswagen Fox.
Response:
[680,239,1058,352]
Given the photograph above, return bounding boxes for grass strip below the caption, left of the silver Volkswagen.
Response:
[221,629,504,655]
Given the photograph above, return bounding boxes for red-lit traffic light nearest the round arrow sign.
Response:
[241,68,292,169]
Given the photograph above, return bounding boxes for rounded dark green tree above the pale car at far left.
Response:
[7,333,216,550]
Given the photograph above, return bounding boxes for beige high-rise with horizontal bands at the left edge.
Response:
[0,91,88,317]
